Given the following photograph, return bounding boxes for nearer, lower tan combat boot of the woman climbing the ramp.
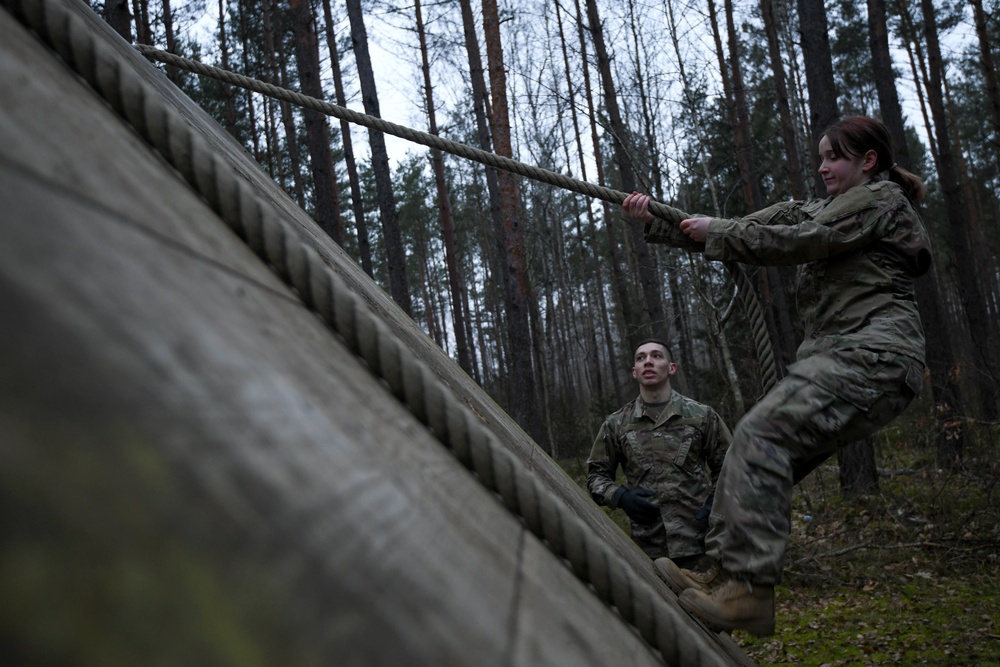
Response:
[679,578,774,637]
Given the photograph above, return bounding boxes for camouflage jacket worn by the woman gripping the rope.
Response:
[647,177,931,363]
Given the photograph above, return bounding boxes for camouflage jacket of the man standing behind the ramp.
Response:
[587,391,732,558]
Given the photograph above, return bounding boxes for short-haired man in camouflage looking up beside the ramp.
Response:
[587,339,731,569]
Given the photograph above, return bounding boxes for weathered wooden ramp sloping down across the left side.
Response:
[0,0,749,667]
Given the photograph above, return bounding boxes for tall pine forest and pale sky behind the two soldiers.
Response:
[91,0,1000,664]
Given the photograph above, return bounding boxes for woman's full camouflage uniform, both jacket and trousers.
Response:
[649,172,931,585]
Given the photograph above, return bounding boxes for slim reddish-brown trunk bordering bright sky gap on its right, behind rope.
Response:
[414,0,472,374]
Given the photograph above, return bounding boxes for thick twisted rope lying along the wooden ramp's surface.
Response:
[7,0,736,666]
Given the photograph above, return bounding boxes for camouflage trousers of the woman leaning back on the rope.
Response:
[706,348,923,585]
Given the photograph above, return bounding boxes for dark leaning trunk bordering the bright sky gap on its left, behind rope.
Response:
[347,0,413,315]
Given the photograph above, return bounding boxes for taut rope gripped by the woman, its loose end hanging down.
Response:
[136,44,778,392]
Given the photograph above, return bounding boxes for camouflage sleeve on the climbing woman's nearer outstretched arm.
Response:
[705,186,891,266]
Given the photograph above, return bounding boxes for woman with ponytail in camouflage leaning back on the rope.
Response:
[623,116,931,636]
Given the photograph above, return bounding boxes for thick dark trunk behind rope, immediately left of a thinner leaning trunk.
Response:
[288,0,344,246]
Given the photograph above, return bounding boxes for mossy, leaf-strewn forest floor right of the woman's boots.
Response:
[564,420,1000,667]
